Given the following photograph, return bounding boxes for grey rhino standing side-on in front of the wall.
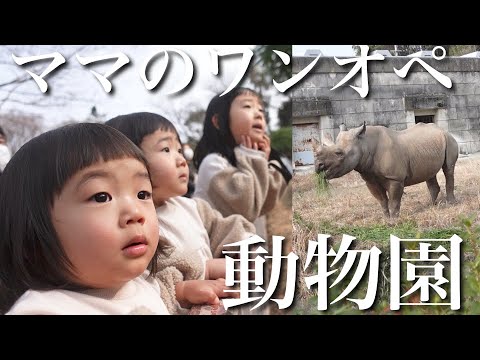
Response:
[315,123,458,217]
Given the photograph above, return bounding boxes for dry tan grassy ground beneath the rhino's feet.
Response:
[293,153,480,228]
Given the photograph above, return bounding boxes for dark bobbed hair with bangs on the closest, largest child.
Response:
[0,123,161,313]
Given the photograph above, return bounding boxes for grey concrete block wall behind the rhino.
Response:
[291,57,480,165]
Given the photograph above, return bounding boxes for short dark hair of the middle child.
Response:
[105,112,181,147]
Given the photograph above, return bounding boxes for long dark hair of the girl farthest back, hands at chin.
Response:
[193,87,292,182]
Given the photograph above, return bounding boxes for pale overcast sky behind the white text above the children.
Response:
[0,45,285,139]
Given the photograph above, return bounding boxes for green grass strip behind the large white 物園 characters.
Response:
[292,215,480,315]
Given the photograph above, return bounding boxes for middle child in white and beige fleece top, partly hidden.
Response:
[106,112,255,316]
